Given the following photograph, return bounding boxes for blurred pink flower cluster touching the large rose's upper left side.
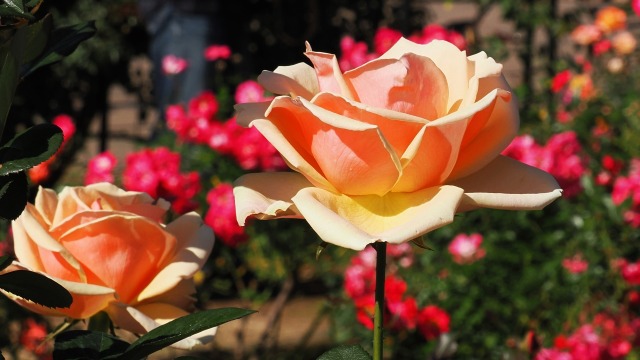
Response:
[166,87,287,171]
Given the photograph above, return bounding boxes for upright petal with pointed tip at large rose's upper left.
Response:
[304,44,355,99]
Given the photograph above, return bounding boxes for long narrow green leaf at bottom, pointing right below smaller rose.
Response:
[120,308,255,360]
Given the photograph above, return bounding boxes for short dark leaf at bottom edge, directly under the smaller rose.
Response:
[53,330,129,360]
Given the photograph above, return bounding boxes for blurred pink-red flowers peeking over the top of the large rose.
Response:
[338,24,467,71]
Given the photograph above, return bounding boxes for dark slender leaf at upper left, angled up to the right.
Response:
[21,21,96,77]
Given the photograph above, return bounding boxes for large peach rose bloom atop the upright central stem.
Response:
[234,38,561,250]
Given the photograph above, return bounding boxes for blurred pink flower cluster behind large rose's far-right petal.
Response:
[502,131,586,197]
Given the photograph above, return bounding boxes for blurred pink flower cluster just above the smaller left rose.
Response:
[122,147,200,214]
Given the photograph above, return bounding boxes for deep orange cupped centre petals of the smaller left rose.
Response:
[58,215,176,302]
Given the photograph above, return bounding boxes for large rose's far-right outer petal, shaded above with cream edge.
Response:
[451,155,562,211]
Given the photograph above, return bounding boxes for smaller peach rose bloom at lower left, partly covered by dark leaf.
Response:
[5,183,215,348]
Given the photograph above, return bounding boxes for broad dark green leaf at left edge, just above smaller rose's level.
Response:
[0,123,63,176]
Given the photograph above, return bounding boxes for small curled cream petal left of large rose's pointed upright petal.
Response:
[258,63,320,100]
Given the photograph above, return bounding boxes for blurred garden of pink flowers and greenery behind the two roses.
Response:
[0,1,640,359]
